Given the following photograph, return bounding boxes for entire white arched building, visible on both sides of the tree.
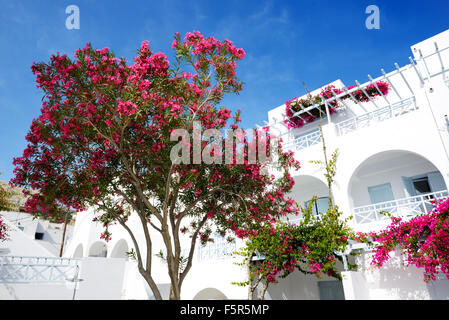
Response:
[2,30,449,299]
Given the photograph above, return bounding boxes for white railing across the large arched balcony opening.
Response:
[354,190,448,224]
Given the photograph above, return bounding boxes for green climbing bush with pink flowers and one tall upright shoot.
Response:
[234,126,357,300]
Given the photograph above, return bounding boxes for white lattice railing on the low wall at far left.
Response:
[0,256,80,283]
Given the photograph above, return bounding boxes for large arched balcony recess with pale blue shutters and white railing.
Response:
[348,150,447,224]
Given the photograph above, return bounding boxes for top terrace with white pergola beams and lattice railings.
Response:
[265,42,449,151]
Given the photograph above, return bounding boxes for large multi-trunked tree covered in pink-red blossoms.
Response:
[11,31,299,299]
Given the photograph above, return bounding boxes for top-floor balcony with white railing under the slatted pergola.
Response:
[266,48,442,151]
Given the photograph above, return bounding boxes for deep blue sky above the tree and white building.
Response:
[0,0,449,180]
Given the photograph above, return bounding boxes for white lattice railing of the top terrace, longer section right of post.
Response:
[336,97,417,136]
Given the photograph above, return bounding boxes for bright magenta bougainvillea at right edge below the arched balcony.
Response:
[358,198,449,282]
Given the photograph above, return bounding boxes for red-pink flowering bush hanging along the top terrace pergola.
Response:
[284,81,390,129]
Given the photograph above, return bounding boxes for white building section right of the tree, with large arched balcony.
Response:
[260,30,449,299]
